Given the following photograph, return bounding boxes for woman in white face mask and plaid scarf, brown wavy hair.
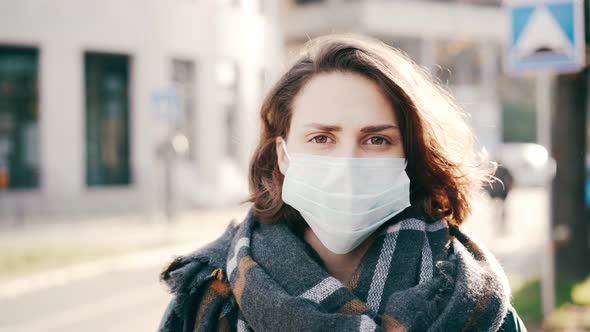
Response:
[160,35,526,331]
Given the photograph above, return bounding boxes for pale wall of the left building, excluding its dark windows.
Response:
[0,0,282,220]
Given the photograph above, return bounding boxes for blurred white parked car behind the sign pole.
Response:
[492,143,555,187]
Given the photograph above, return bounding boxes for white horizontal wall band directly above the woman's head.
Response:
[283,0,507,42]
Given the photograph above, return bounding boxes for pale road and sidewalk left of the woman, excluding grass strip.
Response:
[0,209,249,332]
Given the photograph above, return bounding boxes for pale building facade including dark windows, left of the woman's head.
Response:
[0,0,284,221]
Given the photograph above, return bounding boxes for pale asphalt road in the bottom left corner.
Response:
[0,265,170,332]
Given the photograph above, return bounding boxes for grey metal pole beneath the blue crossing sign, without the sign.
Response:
[536,71,555,317]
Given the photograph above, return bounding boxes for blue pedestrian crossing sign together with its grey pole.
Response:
[504,0,586,317]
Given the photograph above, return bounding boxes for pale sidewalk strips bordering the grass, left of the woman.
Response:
[0,205,248,298]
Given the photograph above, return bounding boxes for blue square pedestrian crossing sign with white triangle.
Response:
[505,0,586,72]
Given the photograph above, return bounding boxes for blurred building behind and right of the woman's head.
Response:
[281,0,535,154]
